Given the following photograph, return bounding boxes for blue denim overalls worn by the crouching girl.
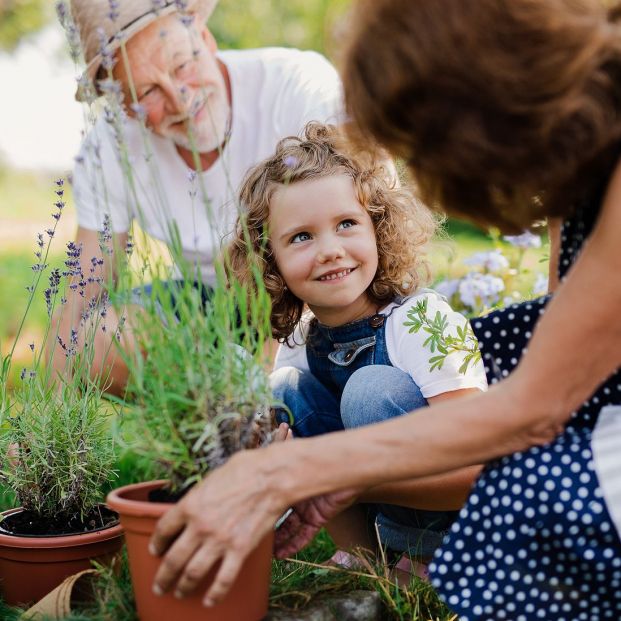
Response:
[272,302,458,558]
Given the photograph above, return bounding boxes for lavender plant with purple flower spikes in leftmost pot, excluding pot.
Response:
[0,180,114,530]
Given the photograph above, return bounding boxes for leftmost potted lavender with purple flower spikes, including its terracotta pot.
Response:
[0,188,122,605]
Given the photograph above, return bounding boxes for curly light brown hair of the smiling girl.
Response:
[227,122,437,341]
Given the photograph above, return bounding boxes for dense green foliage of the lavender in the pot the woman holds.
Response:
[120,239,272,493]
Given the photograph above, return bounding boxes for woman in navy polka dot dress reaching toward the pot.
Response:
[153,0,621,621]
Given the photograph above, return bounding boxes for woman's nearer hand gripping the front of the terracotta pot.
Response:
[150,434,288,606]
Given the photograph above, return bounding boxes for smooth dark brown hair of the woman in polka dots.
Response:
[342,0,621,231]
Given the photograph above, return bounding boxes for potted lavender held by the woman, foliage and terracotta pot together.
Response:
[108,253,272,621]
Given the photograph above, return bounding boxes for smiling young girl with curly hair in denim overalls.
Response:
[226,124,486,559]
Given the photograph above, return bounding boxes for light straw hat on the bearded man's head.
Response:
[71,0,218,99]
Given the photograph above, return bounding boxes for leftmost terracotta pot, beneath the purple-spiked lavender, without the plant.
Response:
[0,509,123,606]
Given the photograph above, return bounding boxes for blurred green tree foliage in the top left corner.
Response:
[0,0,53,52]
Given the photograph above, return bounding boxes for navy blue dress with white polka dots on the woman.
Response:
[430,191,621,621]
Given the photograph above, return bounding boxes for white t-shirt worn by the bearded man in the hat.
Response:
[73,48,342,282]
